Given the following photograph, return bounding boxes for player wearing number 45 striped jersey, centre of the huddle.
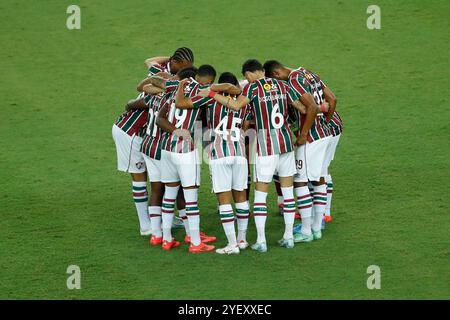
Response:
[175,72,249,254]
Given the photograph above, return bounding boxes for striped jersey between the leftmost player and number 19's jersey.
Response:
[141,92,174,160]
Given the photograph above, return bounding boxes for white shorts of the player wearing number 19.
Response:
[160,150,200,188]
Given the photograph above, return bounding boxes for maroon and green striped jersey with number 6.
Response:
[242,78,298,156]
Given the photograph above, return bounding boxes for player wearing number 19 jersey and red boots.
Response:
[155,66,216,253]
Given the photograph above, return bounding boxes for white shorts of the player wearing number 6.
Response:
[253,151,296,183]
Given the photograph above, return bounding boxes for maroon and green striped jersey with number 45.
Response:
[193,93,251,160]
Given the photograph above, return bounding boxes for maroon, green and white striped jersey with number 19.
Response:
[161,78,209,153]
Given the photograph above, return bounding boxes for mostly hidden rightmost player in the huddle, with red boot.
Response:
[325,111,344,222]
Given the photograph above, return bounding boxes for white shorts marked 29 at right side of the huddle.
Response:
[294,137,331,182]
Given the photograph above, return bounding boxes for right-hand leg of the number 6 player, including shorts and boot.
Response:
[277,152,296,248]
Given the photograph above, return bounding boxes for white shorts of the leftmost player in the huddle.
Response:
[112,124,145,173]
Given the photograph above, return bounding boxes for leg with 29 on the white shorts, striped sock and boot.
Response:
[294,142,313,242]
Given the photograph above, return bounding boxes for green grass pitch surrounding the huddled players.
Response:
[0,0,450,299]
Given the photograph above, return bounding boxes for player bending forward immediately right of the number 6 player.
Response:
[264,60,336,242]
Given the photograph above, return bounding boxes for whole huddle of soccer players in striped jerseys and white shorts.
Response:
[112,47,343,254]
